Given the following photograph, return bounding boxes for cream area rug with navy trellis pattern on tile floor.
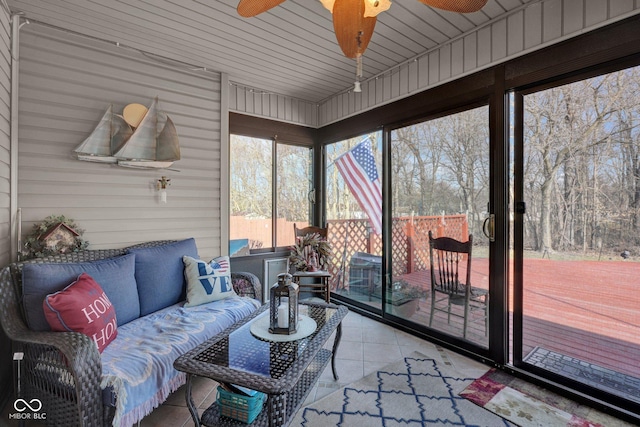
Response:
[291,352,513,427]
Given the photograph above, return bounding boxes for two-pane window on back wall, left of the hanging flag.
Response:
[229,135,312,256]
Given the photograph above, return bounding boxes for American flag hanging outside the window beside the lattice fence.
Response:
[335,138,382,234]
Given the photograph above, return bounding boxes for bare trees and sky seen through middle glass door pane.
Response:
[391,107,489,237]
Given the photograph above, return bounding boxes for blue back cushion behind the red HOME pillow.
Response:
[22,255,140,331]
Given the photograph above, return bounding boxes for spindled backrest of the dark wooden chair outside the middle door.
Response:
[429,230,473,295]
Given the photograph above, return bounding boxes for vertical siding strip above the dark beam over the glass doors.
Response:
[318,0,640,126]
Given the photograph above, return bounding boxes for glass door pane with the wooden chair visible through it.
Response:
[385,106,491,348]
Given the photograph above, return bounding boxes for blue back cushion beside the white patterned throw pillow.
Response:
[129,238,198,316]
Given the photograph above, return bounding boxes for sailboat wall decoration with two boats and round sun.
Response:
[74,97,180,169]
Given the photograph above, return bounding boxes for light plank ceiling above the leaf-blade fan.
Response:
[8,0,541,102]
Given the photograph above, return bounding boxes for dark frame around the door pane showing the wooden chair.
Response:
[322,89,509,366]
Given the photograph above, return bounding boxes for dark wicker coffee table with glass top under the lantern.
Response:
[173,302,348,427]
